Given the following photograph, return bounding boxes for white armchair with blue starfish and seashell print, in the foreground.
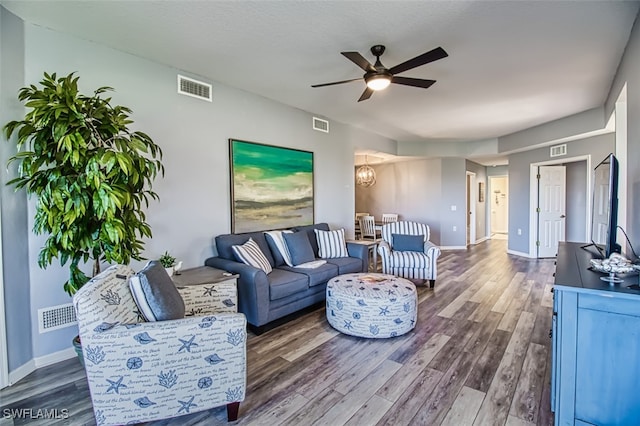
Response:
[73,265,246,425]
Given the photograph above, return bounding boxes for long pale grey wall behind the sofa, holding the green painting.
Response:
[2,18,395,366]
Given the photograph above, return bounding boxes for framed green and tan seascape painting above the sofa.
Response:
[229,139,314,233]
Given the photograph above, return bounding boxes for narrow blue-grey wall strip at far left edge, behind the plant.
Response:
[0,7,33,371]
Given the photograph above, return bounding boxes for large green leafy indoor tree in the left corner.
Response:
[4,73,164,295]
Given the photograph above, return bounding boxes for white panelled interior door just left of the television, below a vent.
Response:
[538,166,567,257]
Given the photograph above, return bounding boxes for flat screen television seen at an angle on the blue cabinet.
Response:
[591,154,620,258]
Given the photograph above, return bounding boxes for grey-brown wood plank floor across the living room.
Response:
[0,240,555,426]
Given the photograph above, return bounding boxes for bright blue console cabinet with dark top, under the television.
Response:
[551,243,640,426]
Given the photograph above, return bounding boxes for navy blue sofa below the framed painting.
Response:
[205,223,368,333]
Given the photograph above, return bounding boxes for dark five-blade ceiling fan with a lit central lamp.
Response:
[311,44,449,102]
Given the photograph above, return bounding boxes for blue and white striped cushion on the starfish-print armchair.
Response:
[129,260,185,321]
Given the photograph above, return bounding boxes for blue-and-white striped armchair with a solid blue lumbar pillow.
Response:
[378,221,441,287]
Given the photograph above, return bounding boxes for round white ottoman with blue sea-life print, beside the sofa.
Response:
[327,273,417,338]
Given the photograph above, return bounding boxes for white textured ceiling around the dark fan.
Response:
[0,0,638,163]
